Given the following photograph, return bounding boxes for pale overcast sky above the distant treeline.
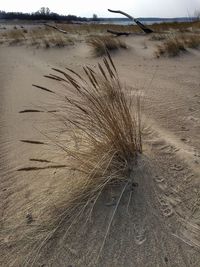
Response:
[0,0,200,17]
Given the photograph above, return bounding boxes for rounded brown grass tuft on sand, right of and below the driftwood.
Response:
[156,38,186,57]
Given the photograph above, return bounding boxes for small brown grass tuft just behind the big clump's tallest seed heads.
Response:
[87,35,127,56]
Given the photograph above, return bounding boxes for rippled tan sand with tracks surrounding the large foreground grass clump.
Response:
[0,36,200,267]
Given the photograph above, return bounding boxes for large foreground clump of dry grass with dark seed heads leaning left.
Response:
[16,54,142,266]
